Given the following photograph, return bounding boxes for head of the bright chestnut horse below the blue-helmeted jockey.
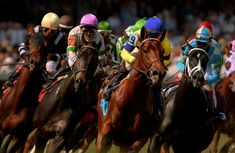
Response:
[133,35,167,86]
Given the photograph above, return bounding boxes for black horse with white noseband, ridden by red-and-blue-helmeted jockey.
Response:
[148,44,218,153]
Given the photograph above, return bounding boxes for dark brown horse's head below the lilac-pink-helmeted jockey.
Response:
[73,45,98,89]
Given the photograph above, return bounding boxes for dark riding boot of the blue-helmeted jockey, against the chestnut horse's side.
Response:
[102,67,128,100]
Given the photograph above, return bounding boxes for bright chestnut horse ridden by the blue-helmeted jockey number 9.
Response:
[96,33,166,153]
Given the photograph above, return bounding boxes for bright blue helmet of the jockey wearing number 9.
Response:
[144,16,165,33]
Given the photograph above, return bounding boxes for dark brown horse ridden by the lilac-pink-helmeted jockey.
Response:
[29,45,98,153]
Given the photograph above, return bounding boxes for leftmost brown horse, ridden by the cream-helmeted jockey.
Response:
[0,33,46,153]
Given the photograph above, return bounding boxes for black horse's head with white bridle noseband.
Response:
[185,44,209,87]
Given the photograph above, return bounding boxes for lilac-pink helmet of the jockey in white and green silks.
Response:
[80,13,98,28]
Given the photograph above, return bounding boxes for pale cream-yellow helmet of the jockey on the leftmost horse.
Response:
[41,12,60,30]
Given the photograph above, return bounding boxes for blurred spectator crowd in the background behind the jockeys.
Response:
[0,0,235,79]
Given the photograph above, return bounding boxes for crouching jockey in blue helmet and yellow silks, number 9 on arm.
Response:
[103,17,171,117]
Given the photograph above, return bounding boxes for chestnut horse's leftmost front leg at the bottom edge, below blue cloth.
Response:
[96,122,112,153]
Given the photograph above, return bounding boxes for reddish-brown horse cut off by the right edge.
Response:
[210,62,235,153]
